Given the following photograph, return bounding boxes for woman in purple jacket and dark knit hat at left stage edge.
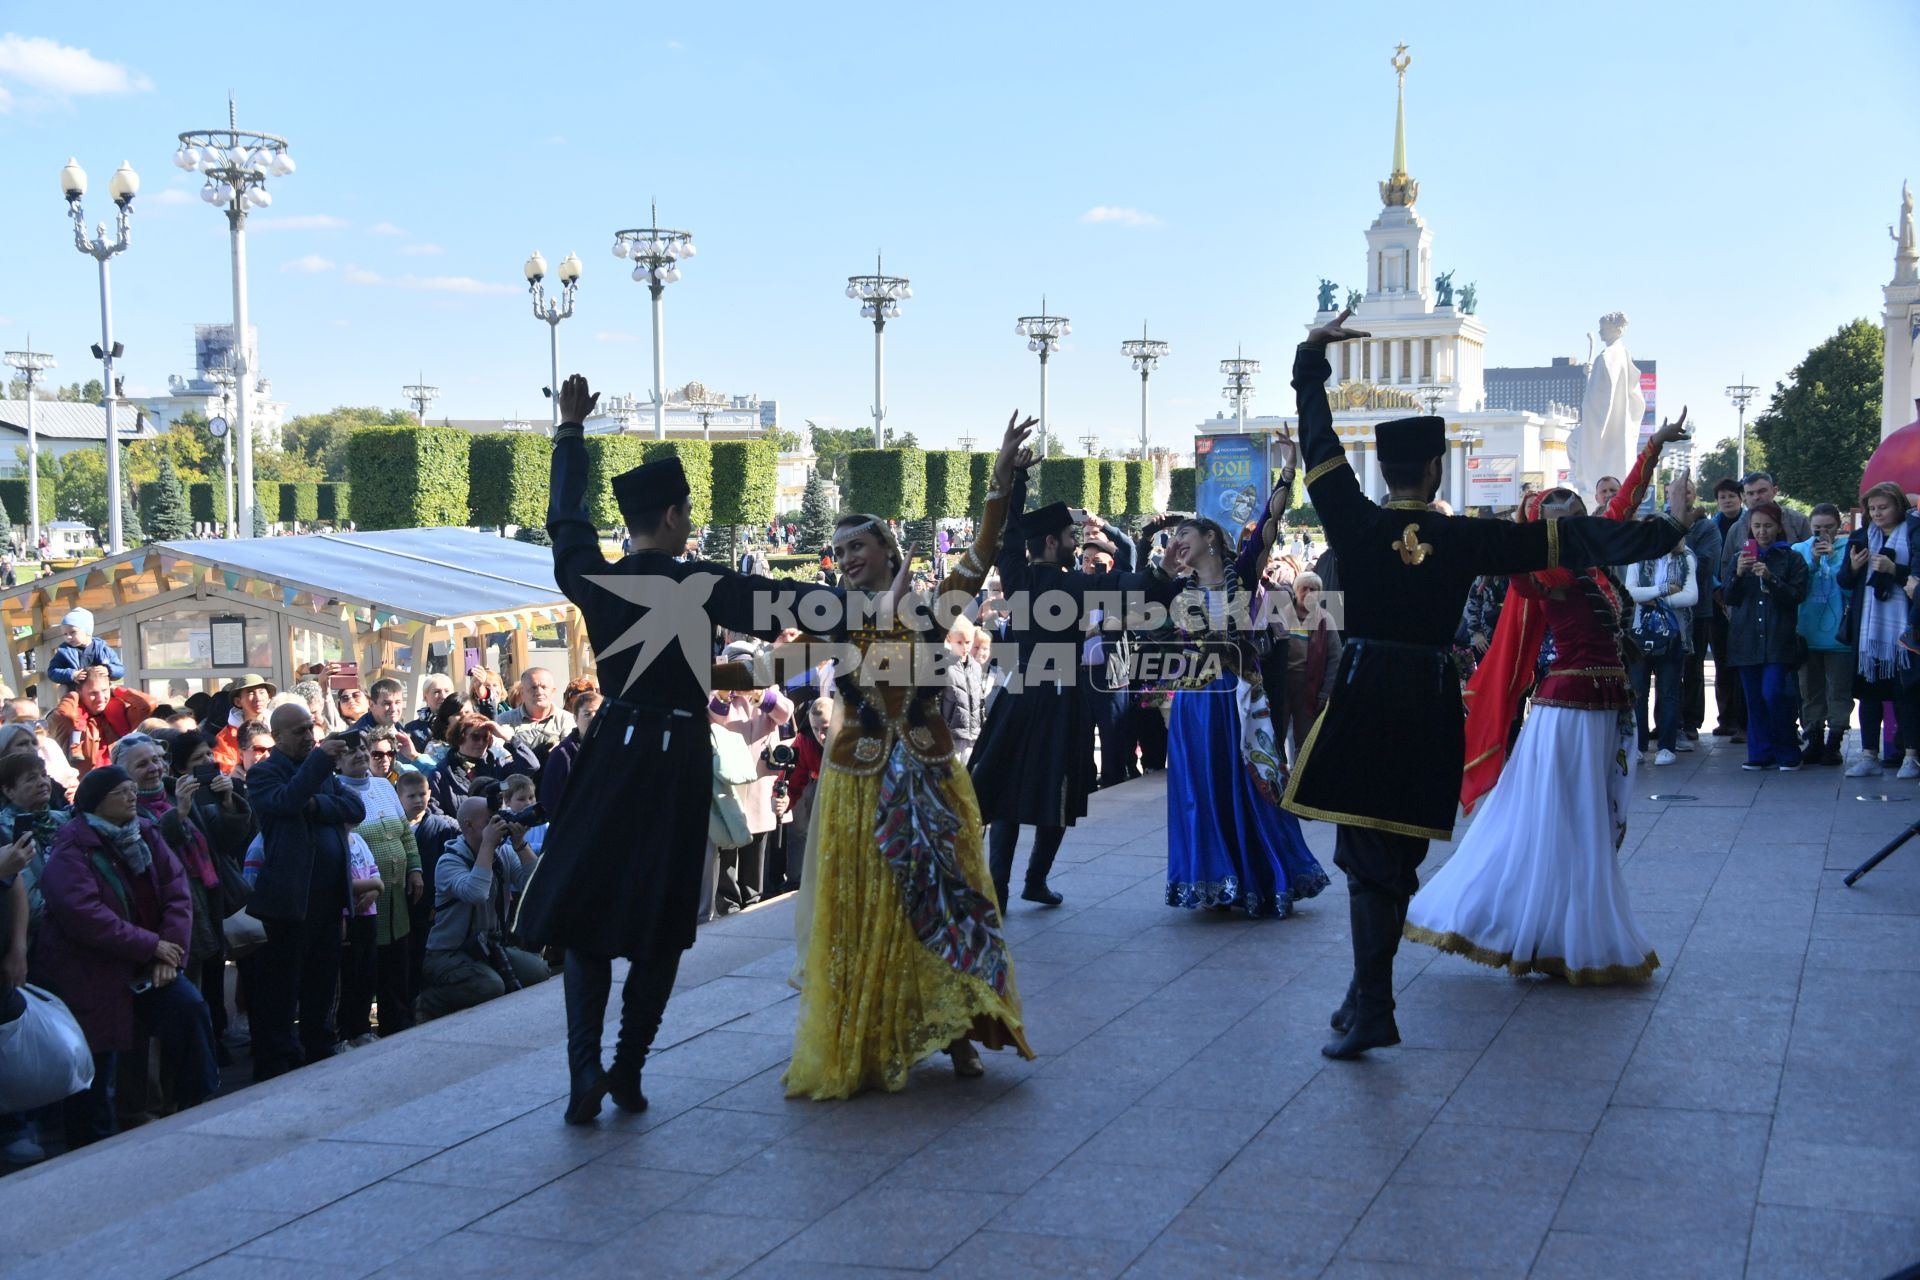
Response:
[33,766,221,1148]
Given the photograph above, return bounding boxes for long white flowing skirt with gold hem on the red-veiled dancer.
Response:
[1405,706,1661,984]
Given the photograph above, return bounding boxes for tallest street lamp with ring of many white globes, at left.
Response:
[173,98,294,537]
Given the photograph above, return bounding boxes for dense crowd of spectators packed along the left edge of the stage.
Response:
[0,652,601,1171]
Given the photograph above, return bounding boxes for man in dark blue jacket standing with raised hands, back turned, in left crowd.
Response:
[246,704,367,1080]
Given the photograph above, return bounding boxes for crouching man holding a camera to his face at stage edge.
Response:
[415,793,551,1023]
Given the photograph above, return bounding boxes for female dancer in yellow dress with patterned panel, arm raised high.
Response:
[785,415,1033,1098]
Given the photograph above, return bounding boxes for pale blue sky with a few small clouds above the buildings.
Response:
[0,0,1920,454]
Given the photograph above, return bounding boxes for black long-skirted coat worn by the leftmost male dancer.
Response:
[515,428,839,960]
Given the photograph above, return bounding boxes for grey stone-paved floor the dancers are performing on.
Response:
[0,739,1920,1280]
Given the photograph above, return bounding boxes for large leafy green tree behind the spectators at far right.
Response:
[1749,320,1884,505]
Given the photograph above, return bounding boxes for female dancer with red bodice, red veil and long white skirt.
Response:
[1405,413,1686,984]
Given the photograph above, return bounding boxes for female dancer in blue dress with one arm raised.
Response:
[1167,466,1327,917]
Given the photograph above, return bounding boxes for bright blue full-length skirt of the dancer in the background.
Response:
[1167,676,1329,917]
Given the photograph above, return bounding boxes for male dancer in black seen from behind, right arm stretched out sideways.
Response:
[1284,311,1693,1057]
